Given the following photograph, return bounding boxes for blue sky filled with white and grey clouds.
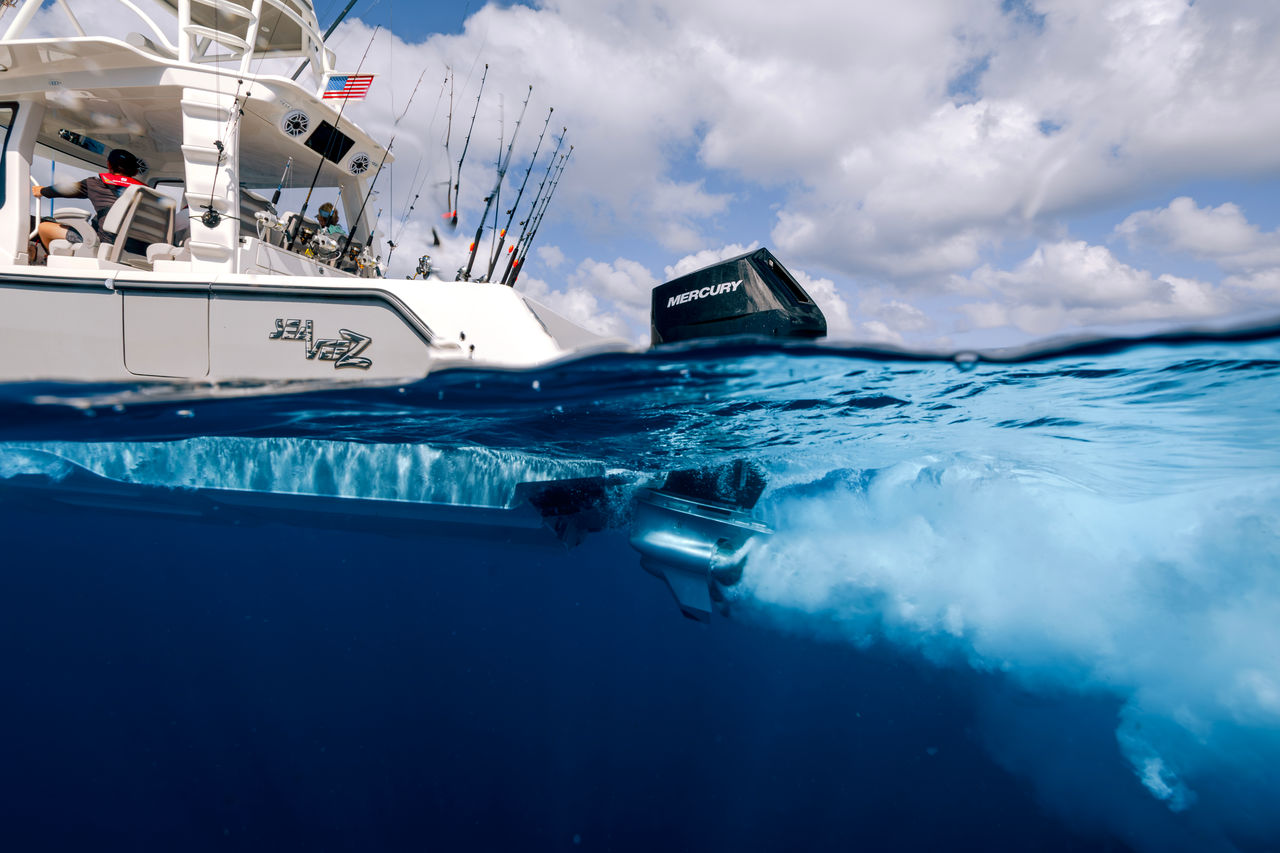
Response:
[22,0,1280,350]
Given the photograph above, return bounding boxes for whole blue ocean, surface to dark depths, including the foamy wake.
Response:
[0,329,1280,850]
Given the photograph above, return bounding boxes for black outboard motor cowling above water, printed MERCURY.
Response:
[650,248,827,345]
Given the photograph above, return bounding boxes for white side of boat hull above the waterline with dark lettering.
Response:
[0,268,626,384]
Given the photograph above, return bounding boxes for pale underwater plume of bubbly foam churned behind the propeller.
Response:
[735,455,1280,831]
